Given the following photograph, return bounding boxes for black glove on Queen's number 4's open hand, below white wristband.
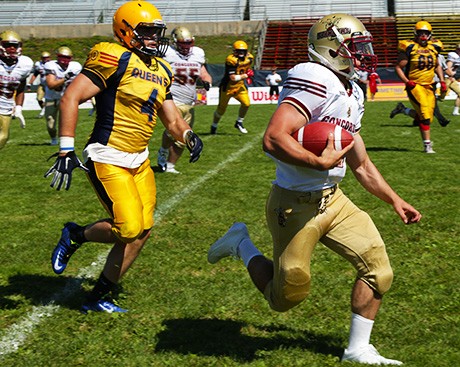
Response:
[44,150,89,191]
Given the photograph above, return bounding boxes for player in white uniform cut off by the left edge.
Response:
[0,31,34,149]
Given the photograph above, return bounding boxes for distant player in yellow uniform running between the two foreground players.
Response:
[211,41,254,134]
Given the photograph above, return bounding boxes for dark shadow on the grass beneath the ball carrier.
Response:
[155,319,343,362]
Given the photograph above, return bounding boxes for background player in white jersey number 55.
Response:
[158,27,212,173]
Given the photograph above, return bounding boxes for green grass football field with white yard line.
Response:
[0,102,460,367]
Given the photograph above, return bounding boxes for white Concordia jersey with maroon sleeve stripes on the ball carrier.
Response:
[269,62,364,191]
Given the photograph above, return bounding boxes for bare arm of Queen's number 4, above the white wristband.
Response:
[59,74,101,137]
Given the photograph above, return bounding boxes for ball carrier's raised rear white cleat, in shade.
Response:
[208,222,249,264]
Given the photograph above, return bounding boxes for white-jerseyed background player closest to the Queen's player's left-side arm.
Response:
[45,46,82,145]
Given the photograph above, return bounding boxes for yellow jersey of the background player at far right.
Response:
[398,40,443,85]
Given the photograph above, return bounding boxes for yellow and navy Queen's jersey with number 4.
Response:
[82,42,173,153]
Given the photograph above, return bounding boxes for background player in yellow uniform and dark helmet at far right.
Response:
[390,21,447,153]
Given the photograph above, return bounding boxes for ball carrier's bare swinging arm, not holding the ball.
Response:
[347,133,422,224]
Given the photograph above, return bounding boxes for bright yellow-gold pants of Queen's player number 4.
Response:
[86,159,156,243]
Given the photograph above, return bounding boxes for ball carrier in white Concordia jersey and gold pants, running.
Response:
[208,14,421,365]
